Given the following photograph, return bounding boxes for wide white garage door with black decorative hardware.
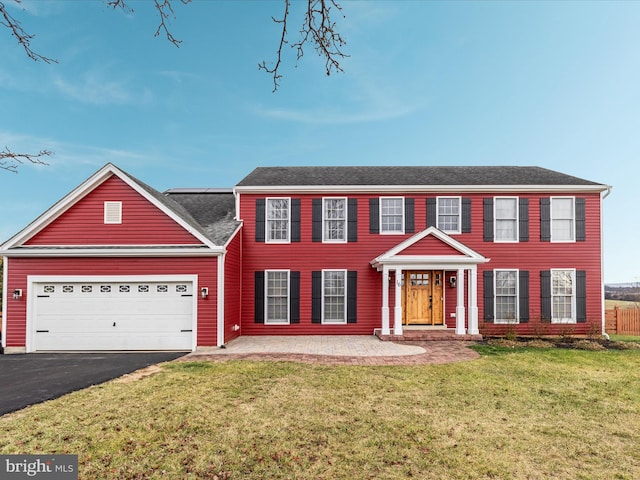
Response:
[32,279,194,351]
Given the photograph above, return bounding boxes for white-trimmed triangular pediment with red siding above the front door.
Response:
[371,227,490,271]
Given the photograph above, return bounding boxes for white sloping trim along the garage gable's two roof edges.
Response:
[0,163,217,251]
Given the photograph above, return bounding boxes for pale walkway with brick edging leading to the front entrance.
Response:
[181,335,479,365]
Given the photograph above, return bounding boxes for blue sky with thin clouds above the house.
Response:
[0,0,640,283]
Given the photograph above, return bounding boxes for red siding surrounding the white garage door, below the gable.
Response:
[5,257,218,347]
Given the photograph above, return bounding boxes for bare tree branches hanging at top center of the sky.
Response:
[258,0,348,92]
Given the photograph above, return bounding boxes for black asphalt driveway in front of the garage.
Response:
[0,352,185,415]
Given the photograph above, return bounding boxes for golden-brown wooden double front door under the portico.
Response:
[402,270,444,325]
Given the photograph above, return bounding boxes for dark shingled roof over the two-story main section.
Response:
[237,166,604,187]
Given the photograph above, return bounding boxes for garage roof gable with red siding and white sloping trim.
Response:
[2,164,218,249]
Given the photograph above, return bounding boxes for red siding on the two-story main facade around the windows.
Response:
[240,191,602,335]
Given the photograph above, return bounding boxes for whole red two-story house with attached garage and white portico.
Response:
[0,164,610,353]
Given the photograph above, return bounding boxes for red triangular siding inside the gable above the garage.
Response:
[26,175,202,245]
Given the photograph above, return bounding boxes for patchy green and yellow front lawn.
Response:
[0,346,640,480]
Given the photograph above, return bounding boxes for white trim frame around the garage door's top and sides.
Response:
[25,275,200,353]
